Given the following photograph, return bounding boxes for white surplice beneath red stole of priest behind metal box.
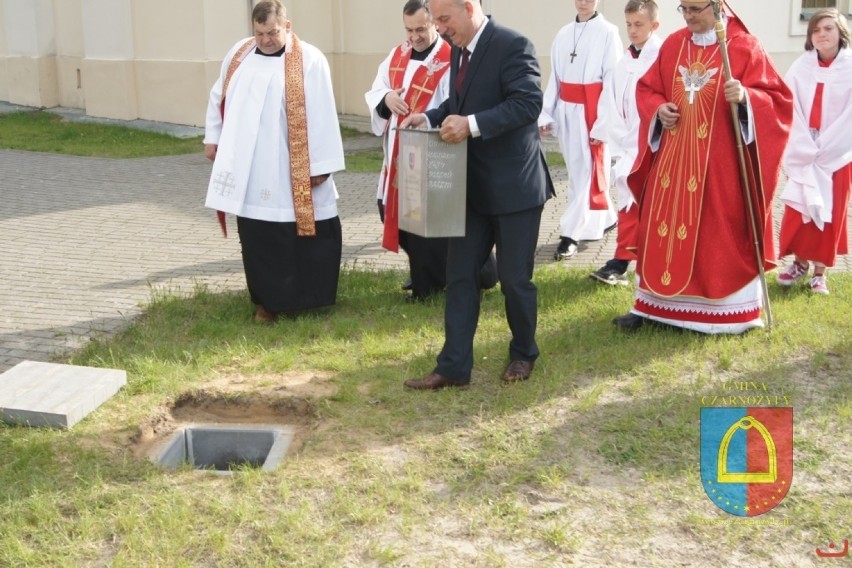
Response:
[364,36,450,203]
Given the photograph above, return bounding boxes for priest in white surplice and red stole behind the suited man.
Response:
[364,0,450,299]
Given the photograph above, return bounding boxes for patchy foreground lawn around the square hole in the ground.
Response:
[0,266,852,566]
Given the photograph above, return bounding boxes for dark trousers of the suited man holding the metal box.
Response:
[435,206,544,381]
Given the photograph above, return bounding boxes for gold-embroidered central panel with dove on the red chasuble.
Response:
[641,39,722,297]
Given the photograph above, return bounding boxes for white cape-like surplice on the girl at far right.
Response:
[781,47,852,230]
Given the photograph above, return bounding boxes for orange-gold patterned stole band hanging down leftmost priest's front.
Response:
[284,34,317,237]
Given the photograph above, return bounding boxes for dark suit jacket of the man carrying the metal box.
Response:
[426,19,553,215]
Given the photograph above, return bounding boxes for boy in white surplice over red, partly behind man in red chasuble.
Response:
[590,0,663,286]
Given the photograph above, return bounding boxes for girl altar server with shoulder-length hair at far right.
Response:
[778,8,852,295]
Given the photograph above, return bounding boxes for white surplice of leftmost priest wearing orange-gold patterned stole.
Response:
[204,35,345,222]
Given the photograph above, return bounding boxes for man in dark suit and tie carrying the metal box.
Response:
[402,0,553,390]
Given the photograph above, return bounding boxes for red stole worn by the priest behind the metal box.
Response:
[382,42,450,252]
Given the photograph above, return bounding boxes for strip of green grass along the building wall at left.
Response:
[0,111,203,158]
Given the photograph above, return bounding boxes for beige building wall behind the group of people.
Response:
[0,0,852,126]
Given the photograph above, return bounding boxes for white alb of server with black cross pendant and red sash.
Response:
[539,14,624,241]
